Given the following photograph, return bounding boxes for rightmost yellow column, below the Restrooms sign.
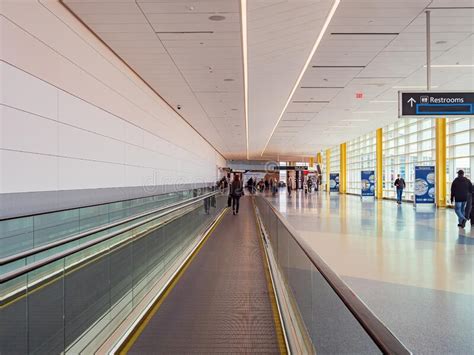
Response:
[435,118,446,207]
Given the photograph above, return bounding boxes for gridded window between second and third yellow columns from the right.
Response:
[347,132,376,195]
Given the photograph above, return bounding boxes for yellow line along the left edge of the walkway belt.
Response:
[118,207,229,354]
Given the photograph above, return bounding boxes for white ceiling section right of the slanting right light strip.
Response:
[265,0,474,155]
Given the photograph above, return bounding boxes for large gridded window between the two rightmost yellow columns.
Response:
[382,118,436,200]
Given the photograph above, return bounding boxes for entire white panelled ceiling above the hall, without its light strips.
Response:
[66,0,474,159]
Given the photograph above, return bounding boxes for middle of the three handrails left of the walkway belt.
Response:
[0,192,214,266]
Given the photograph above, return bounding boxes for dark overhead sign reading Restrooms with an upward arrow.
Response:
[398,91,474,117]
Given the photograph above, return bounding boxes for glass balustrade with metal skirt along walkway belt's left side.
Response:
[0,193,224,354]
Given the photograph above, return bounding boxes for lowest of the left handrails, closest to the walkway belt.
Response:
[0,191,220,284]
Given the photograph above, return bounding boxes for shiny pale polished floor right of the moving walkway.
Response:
[267,190,474,354]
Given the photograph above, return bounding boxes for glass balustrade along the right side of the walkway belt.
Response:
[257,198,400,354]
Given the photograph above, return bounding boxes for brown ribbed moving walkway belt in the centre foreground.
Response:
[121,198,286,354]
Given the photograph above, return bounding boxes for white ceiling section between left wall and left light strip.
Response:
[65,0,246,155]
